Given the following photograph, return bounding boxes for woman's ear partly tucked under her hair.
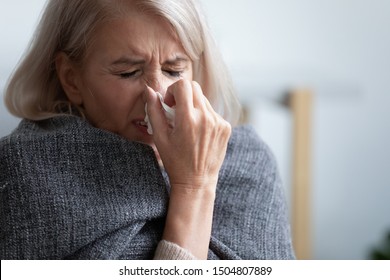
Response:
[55,52,83,105]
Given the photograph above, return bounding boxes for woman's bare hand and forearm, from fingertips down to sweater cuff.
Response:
[145,80,231,258]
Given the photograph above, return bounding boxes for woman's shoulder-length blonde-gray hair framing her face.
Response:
[4,0,241,125]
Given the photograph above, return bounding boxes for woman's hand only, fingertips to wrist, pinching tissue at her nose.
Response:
[147,80,231,189]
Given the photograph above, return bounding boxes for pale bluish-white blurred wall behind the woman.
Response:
[0,0,390,259]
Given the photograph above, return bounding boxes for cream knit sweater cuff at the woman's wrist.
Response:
[154,240,196,260]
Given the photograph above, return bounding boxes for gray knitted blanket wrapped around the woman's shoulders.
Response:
[0,116,294,259]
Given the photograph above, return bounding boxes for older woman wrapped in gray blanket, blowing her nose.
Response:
[0,0,294,259]
